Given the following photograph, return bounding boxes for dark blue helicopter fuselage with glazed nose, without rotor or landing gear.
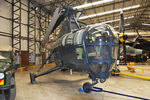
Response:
[49,24,118,82]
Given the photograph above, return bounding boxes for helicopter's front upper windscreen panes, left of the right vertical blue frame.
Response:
[86,27,115,60]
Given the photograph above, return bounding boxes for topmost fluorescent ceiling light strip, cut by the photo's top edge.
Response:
[73,0,113,9]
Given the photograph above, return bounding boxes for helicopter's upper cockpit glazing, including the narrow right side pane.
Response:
[86,26,117,60]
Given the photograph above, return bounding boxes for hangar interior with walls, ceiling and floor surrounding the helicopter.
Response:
[0,0,150,100]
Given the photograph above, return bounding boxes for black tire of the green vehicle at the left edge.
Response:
[5,77,16,100]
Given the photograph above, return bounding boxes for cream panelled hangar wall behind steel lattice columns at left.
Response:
[0,0,49,64]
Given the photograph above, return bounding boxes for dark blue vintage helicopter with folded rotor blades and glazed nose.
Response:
[30,6,124,93]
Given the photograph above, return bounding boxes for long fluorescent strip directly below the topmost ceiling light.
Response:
[79,5,140,19]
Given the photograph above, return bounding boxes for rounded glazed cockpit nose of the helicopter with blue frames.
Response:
[85,24,118,80]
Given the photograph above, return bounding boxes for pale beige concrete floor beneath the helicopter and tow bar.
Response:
[15,65,150,100]
